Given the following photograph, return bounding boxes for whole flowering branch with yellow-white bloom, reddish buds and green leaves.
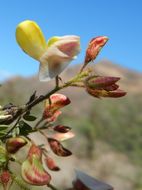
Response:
[0,20,126,190]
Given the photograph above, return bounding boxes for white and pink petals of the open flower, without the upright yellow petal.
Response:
[39,36,80,81]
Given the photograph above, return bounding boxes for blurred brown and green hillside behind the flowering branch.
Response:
[0,60,142,190]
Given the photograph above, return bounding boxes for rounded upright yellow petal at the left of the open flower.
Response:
[16,20,47,60]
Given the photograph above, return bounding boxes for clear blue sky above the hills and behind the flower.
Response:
[0,0,142,80]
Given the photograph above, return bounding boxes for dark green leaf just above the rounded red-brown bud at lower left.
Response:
[19,120,32,136]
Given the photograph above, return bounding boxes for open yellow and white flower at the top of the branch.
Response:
[16,20,80,81]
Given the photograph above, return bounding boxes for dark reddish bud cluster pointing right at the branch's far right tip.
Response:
[85,76,126,98]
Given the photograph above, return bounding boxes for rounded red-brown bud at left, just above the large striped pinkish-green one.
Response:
[6,137,27,154]
